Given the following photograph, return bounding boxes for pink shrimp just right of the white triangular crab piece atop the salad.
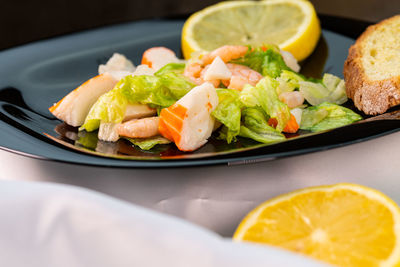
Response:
[222,63,263,91]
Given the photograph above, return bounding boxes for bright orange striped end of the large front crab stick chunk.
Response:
[158,104,187,146]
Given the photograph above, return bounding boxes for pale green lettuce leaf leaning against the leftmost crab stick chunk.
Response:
[79,89,128,132]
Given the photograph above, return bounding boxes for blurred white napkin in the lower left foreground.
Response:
[0,181,325,267]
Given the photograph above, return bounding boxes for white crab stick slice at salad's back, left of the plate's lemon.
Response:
[142,47,182,71]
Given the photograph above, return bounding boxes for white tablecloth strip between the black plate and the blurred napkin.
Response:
[0,132,400,240]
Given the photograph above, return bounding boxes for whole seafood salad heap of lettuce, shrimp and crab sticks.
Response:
[49,45,362,151]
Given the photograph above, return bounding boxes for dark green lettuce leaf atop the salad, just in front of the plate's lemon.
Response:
[232,45,291,78]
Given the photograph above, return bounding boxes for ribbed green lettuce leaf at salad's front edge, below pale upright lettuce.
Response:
[239,108,285,144]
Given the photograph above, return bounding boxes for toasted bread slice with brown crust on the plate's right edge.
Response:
[343,15,400,115]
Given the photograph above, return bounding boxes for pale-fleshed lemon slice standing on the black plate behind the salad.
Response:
[182,0,321,61]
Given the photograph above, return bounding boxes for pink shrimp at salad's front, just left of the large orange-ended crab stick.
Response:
[117,117,160,138]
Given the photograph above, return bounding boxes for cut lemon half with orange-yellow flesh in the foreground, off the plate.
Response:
[233,184,400,267]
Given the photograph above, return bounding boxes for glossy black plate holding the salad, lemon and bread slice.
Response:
[0,16,398,167]
